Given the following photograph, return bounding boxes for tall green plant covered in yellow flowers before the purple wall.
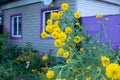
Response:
[41,3,120,80]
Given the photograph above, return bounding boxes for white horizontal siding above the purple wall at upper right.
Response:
[77,0,119,16]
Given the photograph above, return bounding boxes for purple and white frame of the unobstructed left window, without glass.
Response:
[10,13,22,39]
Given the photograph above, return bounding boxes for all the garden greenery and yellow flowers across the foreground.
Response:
[0,3,120,80]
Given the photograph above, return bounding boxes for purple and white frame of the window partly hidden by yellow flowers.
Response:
[40,6,60,39]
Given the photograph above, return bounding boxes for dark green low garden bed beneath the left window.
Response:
[0,33,56,80]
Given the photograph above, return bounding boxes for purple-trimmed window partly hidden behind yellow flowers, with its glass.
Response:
[40,6,60,37]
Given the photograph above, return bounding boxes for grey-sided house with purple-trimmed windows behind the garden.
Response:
[0,0,120,50]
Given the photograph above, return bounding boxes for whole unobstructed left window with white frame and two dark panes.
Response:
[10,14,22,38]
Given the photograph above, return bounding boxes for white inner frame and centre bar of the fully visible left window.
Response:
[12,16,22,37]
